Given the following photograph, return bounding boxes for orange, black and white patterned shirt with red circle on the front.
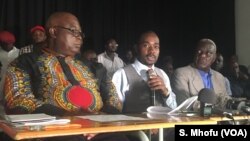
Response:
[5,48,121,113]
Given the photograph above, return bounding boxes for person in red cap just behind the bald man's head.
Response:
[19,25,46,55]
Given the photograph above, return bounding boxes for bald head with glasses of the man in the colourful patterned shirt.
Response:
[45,12,83,56]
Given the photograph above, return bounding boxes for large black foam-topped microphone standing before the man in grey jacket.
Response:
[198,88,216,117]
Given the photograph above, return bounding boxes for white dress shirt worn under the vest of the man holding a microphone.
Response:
[112,59,177,109]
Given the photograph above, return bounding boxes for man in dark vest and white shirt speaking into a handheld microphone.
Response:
[112,31,176,140]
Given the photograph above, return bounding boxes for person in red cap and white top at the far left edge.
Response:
[0,31,19,100]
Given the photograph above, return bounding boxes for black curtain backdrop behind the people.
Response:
[0,0,235,67]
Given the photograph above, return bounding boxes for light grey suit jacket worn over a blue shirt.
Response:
[171,65,231,109]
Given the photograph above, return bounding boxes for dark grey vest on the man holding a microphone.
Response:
[122,65,164,113]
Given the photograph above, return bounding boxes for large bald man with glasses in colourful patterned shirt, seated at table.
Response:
[4,12,128,141]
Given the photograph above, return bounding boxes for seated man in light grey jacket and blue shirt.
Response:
[171,39,231,110]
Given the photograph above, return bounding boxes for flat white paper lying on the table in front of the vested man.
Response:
[77,115,148,122]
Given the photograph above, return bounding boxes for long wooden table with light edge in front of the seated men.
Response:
[0,114,217,140]
